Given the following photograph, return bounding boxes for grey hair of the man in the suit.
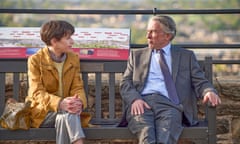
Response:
[150,15,177,40]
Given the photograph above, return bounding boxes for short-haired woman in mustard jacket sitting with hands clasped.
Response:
[26,20,87,144]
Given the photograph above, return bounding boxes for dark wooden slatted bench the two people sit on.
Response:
[0,57,216,144]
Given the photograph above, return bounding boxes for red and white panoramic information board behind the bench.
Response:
[0,27,130,60]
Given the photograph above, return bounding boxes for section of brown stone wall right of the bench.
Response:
[214,77,240,144]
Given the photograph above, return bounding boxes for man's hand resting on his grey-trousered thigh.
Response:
[131,99,151,115]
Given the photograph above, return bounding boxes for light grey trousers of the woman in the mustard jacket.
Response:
[40,112,85,144]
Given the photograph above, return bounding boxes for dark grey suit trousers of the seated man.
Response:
[127,94,183,144]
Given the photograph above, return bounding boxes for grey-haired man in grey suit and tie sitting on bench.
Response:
[120,16,221,144]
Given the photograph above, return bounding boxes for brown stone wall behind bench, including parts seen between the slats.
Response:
[0,77,240,144]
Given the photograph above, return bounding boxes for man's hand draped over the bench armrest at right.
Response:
[203,92,221,106]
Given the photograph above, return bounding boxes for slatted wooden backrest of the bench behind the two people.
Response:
[0,57,212,125]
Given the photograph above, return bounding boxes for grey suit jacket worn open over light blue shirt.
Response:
[120,46,216,125]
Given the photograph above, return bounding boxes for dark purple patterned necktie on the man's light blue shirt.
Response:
[159,50,179,104]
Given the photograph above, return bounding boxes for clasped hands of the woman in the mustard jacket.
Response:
[59,94,83,115]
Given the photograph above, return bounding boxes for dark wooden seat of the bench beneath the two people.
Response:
[0,121,208,141]
